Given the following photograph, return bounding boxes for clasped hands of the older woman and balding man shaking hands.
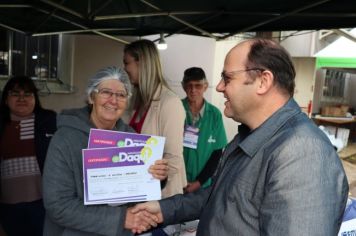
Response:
[124,201,163,234]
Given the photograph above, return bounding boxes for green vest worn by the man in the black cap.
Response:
[182,98,227,187]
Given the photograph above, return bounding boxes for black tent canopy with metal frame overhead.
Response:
[0,0,356,40]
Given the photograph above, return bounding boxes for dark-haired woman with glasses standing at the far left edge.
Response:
[0,76,56,236]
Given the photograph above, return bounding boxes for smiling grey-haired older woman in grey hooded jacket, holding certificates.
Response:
[43,67,167,236]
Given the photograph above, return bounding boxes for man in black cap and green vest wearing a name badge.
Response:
[182,67,227,192]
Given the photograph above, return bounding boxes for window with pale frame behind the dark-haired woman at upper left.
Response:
[0,29,73,94]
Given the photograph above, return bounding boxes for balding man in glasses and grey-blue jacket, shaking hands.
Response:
[133,39,348,236]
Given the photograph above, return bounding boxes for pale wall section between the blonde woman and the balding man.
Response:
[160,35,242,141]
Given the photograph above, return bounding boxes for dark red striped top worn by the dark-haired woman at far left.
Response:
[0,116,42,204]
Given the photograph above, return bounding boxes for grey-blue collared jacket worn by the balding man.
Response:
[160,99,348,236]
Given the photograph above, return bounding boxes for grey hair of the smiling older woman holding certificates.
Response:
[87,66,131,97]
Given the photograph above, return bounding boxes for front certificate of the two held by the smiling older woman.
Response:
[82,146,163,205]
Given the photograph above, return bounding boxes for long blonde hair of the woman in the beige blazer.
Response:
[124,39,169,109]
